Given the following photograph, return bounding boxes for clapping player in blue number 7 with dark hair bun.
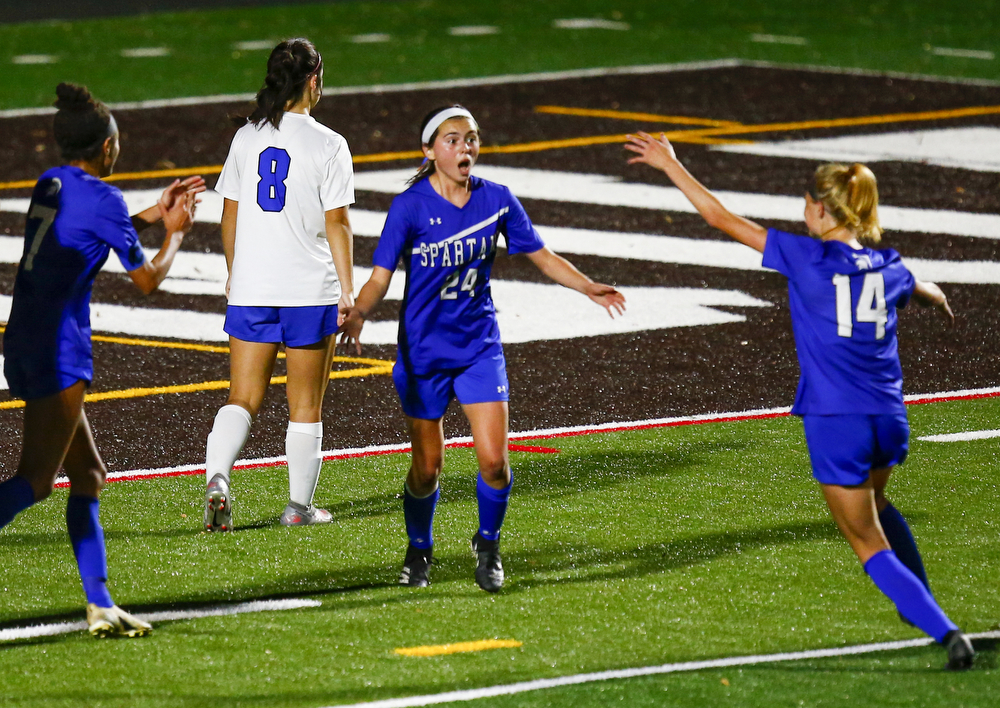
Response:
[0,83,205,637]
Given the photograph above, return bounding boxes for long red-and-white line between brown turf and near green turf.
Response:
[55,387,1000,488]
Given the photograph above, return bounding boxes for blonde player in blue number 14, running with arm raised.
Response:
[625,132,975,670]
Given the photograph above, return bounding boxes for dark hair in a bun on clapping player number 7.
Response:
[52,83,118,162]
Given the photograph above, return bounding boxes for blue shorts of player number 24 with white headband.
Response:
[392,352,509,420]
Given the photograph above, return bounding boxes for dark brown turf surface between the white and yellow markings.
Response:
[0,67,1000,477]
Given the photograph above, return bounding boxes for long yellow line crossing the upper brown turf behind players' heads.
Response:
[0,101,1000,190]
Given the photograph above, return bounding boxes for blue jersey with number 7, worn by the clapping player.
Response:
[4,166,145,381]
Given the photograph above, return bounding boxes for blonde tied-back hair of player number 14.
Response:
[816,162,882,246]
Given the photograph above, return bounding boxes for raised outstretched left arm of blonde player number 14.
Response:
[625,132,767,253]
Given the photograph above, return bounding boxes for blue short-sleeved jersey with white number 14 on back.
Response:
[763,229,916,415]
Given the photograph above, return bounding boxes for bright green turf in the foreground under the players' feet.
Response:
[0,398,1000,708]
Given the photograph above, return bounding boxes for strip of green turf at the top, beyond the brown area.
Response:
[0,0,1000,109]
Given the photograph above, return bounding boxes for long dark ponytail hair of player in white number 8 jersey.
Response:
[233,37,323,128]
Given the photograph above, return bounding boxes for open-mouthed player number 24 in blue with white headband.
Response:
[342,105,625,592]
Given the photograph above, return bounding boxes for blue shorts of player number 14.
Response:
[802,414,910,487]
